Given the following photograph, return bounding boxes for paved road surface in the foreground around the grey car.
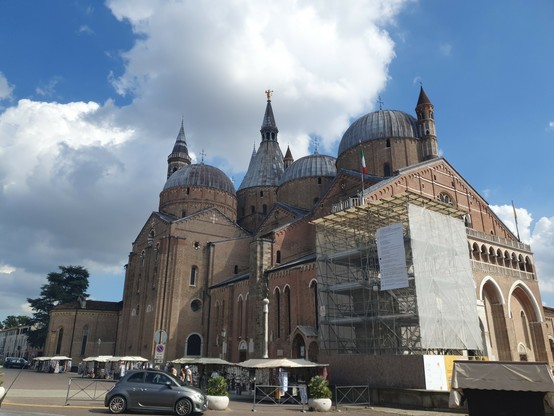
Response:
[0,369,464,416]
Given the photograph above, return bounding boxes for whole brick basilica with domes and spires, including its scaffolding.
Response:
[45,88,554,388]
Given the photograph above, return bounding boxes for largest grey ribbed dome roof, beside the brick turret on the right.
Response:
[339,110,418,156]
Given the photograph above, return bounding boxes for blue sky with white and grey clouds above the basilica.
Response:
[0,0,554,320]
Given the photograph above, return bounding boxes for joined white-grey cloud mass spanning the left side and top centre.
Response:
[0,0,406,318]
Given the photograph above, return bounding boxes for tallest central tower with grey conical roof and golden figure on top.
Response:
[237,90,285,233]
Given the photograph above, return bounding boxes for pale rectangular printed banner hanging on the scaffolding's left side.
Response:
[377,223,408,290]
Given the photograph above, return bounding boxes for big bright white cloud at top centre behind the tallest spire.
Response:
[105,1,403,172]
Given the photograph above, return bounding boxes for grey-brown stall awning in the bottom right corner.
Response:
[452,361,554,392]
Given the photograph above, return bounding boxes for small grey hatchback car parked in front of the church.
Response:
[104,370,208,416]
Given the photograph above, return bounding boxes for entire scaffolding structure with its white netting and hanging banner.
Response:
[314,192,483,355]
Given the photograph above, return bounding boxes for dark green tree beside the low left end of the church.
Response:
[27,266,89,348]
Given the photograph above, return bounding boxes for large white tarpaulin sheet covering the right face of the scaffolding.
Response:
[408,204,483,351]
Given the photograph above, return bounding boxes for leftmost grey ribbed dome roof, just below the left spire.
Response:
[163,163,235,195]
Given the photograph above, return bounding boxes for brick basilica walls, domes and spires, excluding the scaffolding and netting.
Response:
[45,88,554,388]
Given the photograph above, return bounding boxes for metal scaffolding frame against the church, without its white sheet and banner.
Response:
[314,192,480,355]
